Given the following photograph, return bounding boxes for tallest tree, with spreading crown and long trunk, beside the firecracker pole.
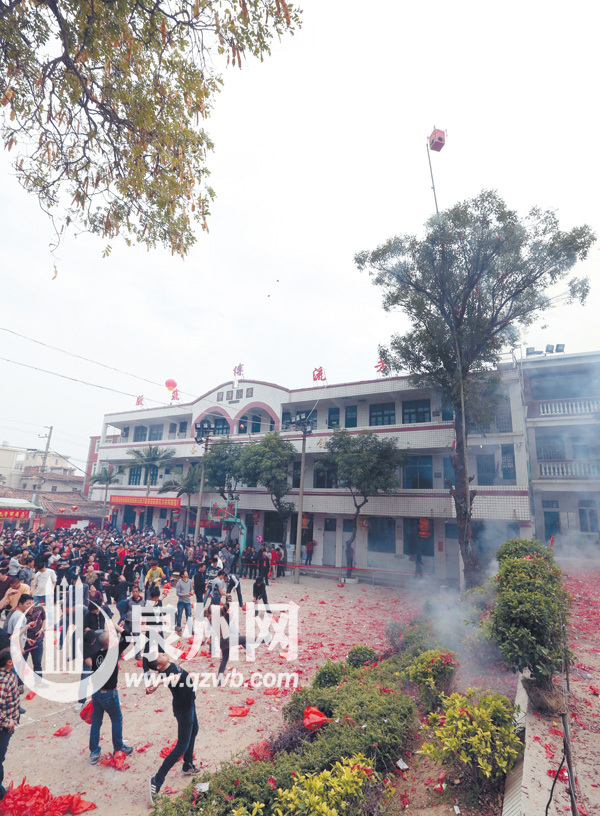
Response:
[356,191,595,585]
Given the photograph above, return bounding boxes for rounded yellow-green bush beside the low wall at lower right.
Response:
[422,689,522,784]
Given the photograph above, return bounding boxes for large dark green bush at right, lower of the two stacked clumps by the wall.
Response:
[491,589,566,688]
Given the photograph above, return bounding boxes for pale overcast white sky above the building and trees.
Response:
[0,0,600,468]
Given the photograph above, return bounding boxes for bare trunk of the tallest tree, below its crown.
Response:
[450,406,481,588]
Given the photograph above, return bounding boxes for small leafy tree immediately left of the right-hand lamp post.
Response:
[241,431,298,545]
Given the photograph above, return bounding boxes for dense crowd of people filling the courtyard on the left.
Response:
[0,526,287,802]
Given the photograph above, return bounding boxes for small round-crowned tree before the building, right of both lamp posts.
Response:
[315,429,407,564]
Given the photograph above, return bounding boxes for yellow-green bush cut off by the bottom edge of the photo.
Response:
[233,754,390,816]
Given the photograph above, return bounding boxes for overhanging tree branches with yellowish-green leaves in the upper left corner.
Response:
[0,0,300,255]
